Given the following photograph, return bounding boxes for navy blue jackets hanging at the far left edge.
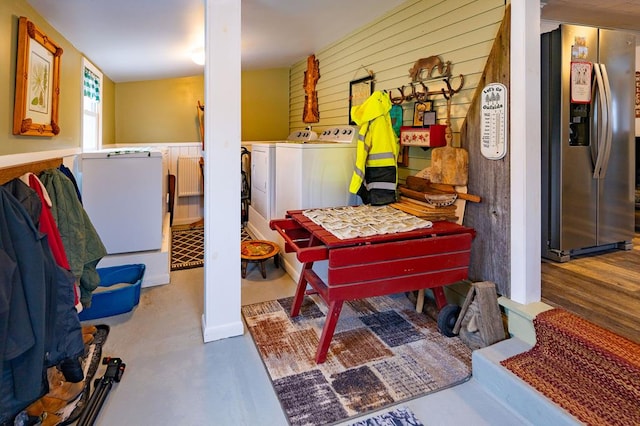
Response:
[0,179,84,423]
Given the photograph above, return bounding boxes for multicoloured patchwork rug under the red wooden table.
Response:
[242,294,471,426]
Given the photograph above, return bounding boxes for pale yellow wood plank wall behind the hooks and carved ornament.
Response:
[289,0,505,179]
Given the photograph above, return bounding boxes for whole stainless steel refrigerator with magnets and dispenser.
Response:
[541,25,636,262]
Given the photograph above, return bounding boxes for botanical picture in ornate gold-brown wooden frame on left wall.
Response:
[13,17,62,136]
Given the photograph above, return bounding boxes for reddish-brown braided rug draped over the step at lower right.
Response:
[502,309,640,425]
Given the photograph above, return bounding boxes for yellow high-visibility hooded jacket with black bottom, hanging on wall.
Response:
[349,91,399,205]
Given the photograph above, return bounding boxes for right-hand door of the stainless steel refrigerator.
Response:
[597,29,636,245]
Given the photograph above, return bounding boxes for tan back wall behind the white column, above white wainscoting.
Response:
[115,68,289,144]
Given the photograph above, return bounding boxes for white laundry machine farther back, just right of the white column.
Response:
[247,130,318,241]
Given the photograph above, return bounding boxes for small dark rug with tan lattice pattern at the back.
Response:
[171,226,252,271]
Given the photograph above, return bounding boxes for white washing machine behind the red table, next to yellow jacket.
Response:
[274,126,359,280]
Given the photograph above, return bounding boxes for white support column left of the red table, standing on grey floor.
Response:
[202,0,244,342]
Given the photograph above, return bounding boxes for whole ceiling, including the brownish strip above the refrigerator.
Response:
[27,0,640,83]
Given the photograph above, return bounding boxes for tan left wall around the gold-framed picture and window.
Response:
[0,0,113,155]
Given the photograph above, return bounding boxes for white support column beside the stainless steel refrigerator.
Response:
[509,0,541,304]
